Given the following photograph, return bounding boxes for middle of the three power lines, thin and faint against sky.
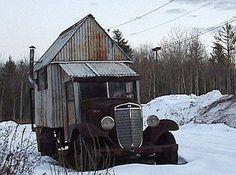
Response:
[126,0,216,37]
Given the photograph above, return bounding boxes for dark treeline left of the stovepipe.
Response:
[0,57,30,122]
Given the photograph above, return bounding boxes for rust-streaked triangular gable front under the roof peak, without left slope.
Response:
[53,15,127,61]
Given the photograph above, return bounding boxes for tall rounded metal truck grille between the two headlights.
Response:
[115,103,143,148]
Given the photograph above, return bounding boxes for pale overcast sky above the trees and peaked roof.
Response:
[0,0,236,61]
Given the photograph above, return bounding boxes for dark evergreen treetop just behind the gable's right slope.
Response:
[112,29,133,58]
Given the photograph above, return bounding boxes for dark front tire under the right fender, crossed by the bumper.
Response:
[155,132,178,164]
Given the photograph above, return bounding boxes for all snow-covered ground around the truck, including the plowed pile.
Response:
[0,91,236,175]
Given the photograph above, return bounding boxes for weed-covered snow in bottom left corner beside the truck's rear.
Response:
[0,121,41,174]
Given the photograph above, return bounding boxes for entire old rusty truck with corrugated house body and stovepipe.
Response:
[29,15,178,169]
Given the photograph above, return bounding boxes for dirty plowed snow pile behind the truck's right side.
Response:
[143,90,236,127]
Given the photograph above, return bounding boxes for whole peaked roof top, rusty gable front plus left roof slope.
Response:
[35,15,129,70]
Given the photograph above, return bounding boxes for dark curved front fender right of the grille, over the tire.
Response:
[143,119,179,145]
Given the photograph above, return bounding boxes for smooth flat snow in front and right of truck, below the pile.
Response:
[115,124,236,175]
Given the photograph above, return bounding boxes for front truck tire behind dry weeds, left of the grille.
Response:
[67,130,114,171]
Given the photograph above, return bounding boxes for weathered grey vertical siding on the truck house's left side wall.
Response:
[35,64,69,128]
